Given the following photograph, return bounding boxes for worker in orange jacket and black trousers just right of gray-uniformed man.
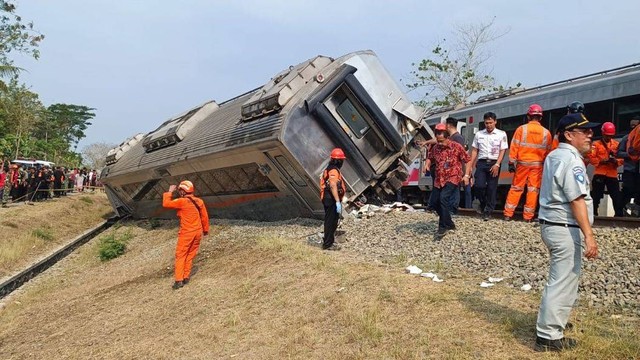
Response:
[589,121,624,216]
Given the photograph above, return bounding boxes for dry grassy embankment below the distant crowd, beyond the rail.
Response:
[0,193,112,280]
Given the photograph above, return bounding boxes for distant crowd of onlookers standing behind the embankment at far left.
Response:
[0,160,100,207]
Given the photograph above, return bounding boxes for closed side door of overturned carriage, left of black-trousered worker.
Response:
[265,150,324,213]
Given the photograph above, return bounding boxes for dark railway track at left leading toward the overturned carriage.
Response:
[0,216,120,299]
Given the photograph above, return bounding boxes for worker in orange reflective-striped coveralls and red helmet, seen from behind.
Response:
[504,104,552,222]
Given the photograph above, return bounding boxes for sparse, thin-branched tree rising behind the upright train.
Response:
[407,18,520,109]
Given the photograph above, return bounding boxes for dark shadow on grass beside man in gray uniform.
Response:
[459,292,538,347]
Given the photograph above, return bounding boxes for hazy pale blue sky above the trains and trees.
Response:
[16,0,640,148]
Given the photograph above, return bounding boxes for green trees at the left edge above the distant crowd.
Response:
[0,0,95,166]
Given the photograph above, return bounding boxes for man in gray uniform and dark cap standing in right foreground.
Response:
[535,113,599,351]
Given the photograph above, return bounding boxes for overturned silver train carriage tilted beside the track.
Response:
[101,51,430,220]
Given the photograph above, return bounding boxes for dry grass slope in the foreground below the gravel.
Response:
[0,217,640,359]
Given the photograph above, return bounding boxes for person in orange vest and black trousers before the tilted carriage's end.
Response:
[320,148,347,250]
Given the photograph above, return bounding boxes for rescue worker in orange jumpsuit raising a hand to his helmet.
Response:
[162,180,209,290]
